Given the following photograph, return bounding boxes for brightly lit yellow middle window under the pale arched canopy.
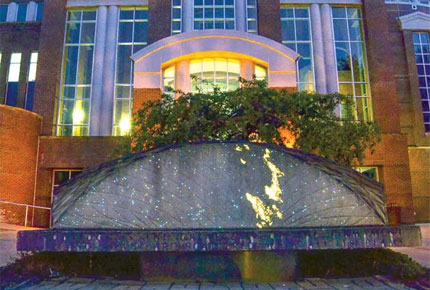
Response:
[190,58,240,93]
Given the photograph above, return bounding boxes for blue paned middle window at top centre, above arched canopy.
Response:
[194,0,235,30]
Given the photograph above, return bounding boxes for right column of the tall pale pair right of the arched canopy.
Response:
[321,4,338,93]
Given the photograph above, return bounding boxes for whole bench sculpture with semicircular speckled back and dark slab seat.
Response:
[18,142,421,279]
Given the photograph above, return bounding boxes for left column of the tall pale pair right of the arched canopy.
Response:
[311,4,327,94]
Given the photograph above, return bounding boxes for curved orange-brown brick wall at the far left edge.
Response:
[0,105,42,225]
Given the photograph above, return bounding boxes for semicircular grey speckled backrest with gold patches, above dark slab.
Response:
[52,141,387,229]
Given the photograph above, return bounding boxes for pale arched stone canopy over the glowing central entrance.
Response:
[132,29,299,88]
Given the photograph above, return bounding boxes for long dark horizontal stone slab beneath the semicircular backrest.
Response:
[17,225,421,252]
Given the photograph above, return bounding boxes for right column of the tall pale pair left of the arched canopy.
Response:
[100,6,119,136]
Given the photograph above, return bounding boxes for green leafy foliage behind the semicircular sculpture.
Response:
[116,79,380,165]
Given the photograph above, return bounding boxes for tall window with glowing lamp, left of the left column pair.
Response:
[57,10,97,136]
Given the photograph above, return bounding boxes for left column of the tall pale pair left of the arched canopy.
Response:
[90,6,107,136]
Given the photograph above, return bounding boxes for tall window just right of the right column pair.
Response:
[332,7,373,121]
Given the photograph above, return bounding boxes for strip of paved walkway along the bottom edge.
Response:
[12,276,425,290]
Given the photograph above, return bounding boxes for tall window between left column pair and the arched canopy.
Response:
[113,8,148,136]
